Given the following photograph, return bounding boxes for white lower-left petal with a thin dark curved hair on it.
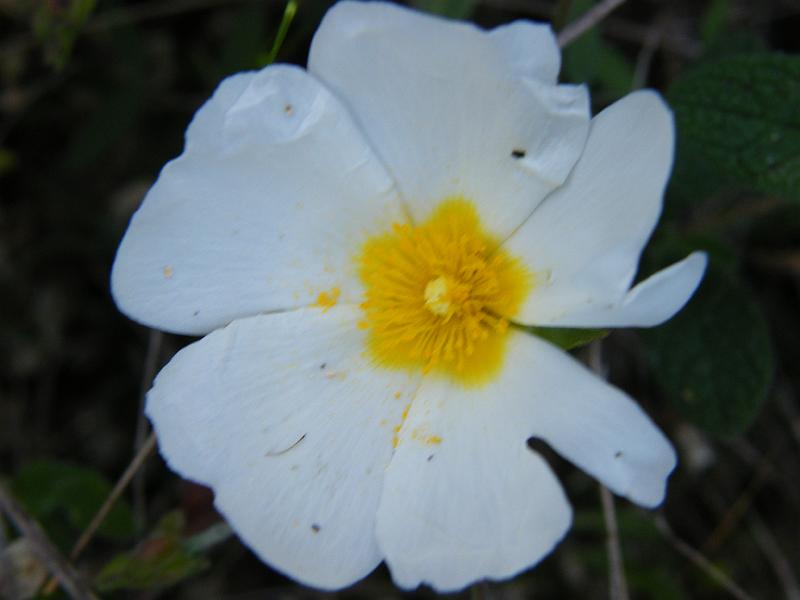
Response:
[147,306,418,589]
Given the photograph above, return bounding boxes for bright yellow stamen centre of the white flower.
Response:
[359,198,532,386]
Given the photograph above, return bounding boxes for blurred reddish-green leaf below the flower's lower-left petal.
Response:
[94,512,209,592]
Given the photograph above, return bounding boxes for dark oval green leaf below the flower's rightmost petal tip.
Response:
[642,262,774,435]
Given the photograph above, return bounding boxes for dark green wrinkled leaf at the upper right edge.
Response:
[668,53,800,200]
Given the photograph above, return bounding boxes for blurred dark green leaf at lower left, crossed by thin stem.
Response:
[12,460,135,541]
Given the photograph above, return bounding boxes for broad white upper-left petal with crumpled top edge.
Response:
[112,65,403,334]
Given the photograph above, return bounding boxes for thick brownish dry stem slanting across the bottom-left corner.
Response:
[0,485,98,600]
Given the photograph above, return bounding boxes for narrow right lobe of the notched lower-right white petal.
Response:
[520,337,676,507]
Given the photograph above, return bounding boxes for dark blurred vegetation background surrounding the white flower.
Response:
[0,0,800,600]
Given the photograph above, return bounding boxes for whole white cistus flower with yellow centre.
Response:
[112,2,705,591]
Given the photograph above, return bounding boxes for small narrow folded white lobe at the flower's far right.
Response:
[550,252,708,327]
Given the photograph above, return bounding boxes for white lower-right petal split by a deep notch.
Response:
[377,333,675,592]
